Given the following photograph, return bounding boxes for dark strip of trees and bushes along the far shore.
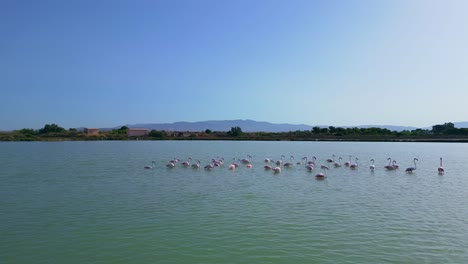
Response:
[0,122,468,142]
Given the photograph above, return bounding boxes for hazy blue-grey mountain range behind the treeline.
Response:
[117,119,424,132]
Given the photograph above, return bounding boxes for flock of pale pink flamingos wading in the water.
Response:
[144,155,445,179]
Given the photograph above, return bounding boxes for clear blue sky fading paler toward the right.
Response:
[0,0,468,130]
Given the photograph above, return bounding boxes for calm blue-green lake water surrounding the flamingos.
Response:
[0,141,468,263]
